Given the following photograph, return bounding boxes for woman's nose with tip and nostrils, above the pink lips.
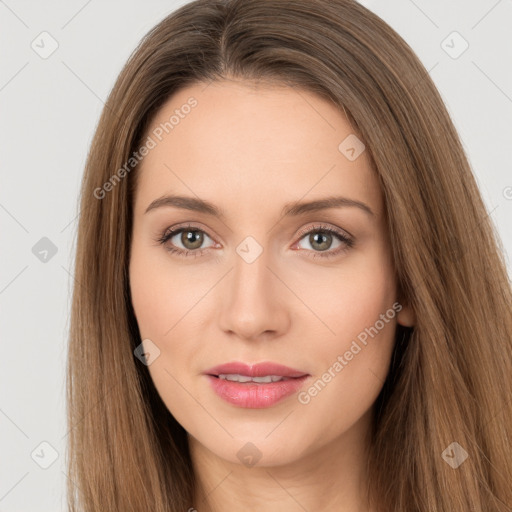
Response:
[219,246,292,340]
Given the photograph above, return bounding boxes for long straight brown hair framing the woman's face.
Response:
[67,0,512,512]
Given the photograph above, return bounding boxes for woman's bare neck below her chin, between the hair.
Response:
[189,410,372,512]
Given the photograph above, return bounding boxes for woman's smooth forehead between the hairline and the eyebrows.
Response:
[136,81,382,218]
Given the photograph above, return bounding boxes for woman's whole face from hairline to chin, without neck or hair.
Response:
[129,81,411,466]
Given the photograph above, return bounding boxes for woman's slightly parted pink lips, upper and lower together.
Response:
[204,362,310,409]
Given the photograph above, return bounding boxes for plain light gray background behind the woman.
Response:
[0,0,512,512]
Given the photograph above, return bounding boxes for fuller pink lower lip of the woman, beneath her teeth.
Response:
[207,375,308,409]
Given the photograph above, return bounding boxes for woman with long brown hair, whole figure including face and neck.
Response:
[68,0,512,512]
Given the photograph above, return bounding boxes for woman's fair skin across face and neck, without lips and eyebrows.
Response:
[129,80,414,512]
